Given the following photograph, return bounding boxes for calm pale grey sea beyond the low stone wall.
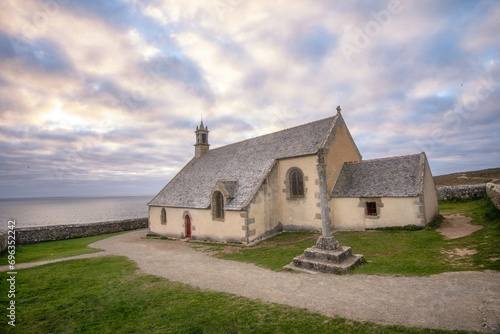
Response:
[0,195,154,229]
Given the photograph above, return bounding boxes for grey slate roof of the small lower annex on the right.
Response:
[332,153,426,197]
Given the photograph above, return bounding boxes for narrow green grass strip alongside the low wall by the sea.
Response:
[0,232,123,265]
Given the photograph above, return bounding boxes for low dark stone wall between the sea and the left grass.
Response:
[11,218,148,245]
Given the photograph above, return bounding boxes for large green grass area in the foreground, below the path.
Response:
[0,257,474,333]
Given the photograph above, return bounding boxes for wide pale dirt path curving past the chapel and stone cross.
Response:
[84,230,500,332]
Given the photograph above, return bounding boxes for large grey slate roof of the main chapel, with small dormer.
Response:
[149,116,339,210]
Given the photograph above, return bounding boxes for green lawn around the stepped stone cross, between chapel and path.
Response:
[205,198,500,276]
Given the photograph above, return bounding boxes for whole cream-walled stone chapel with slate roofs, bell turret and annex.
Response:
[148,108,439,243]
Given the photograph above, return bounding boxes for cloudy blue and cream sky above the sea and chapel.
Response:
[0,0,500,198]
